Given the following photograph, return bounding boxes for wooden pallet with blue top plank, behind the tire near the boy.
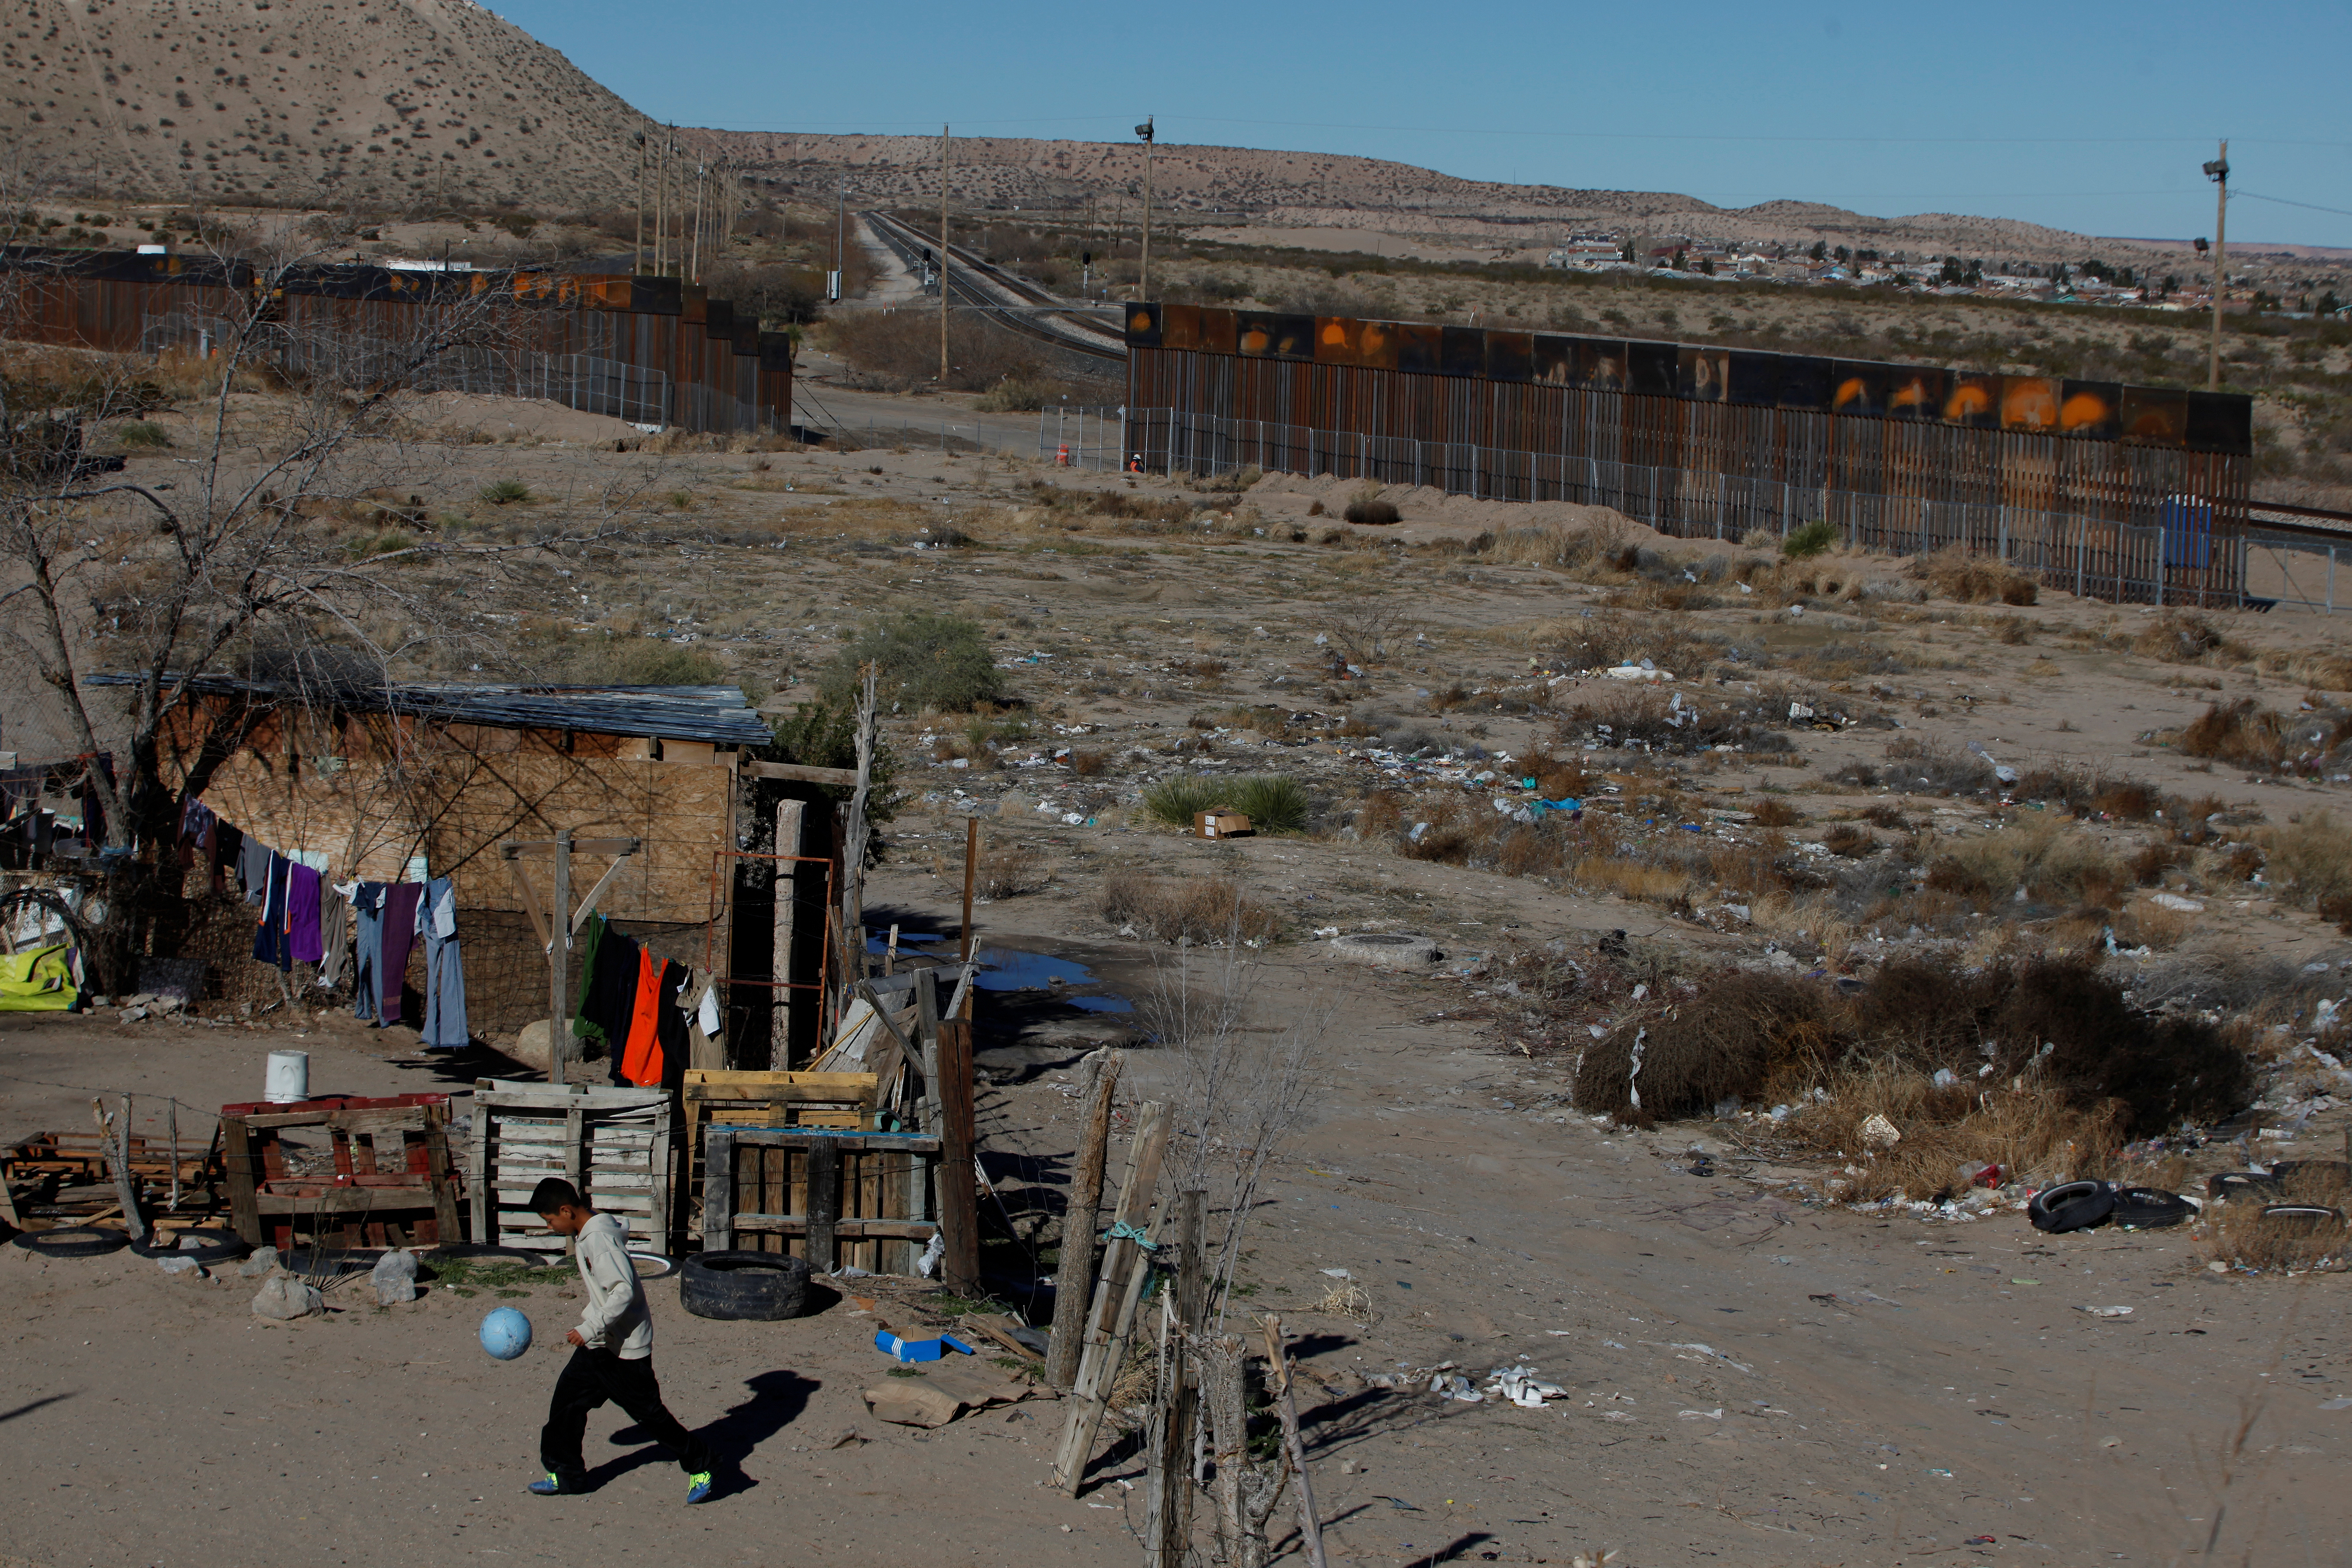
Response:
[703,1121,941,1274]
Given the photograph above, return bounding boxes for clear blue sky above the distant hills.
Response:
[499,0,2352,247]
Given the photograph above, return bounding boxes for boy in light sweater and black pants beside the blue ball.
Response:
[531,1176,710,1505]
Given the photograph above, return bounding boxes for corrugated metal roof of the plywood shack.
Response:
[82,675,771,745]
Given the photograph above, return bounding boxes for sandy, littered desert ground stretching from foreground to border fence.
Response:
[0,383,2352,1568]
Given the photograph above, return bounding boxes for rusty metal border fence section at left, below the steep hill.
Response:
[0,247,793,433]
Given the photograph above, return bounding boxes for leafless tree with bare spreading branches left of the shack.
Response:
[0,231,541,973]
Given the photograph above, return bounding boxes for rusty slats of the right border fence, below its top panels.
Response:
[1122,331,2251,604]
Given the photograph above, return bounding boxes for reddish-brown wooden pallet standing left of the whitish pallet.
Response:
[221,1093,463,1248]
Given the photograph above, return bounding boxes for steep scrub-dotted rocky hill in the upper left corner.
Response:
[0,0,640,209]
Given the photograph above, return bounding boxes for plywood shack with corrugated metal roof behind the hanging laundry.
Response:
[96,677,769,1037]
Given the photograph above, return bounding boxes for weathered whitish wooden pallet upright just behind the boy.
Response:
[473,1079,670,1253]
